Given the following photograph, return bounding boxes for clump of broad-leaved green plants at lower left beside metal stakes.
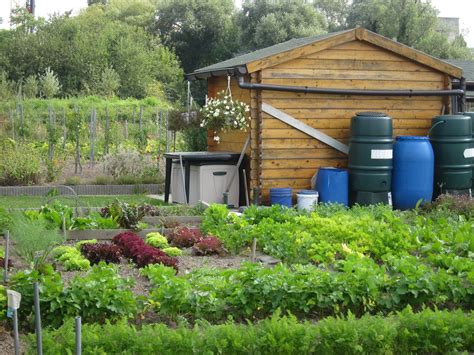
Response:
[11,263,138,327]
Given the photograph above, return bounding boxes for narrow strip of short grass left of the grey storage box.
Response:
[0,195,165,209]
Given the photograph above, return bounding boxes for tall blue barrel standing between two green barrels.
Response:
[392,136,434,210]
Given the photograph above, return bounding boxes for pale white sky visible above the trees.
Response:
[0,0,474,48]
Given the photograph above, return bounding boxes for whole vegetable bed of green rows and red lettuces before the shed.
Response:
[0,198,474,353]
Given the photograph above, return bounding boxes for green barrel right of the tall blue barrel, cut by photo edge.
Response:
[430,115,473,196]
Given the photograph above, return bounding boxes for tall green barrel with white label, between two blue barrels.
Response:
[348,112,393,205]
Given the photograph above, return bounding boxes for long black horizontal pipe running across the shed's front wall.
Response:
[237,75,465,97]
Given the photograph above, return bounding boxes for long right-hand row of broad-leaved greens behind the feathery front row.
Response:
[143,255,474,320]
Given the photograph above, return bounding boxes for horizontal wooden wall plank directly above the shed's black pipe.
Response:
[262,65,443,82]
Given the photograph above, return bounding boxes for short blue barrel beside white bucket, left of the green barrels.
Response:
[315,168,349,206]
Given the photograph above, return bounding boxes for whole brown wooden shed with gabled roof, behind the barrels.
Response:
[187,28,462,200]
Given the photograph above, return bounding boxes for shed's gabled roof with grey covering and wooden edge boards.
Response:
[186,28,462,80]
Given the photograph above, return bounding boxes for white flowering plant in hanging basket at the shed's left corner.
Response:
[201,91,250,142]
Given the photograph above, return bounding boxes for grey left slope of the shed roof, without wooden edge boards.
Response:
[190,30,353,75]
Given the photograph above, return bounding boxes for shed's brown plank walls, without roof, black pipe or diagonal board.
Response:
[209,40,450,200]
